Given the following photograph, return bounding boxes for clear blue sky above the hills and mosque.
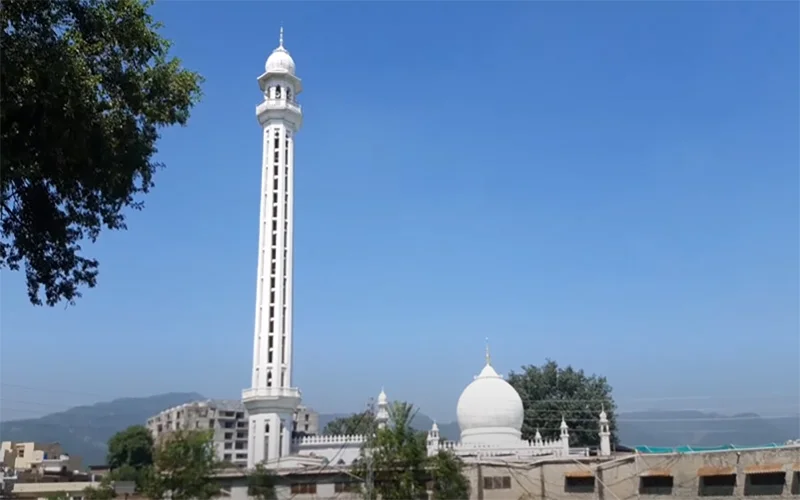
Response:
[0,1,800,420]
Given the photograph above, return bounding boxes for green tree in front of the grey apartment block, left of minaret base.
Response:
[142,430,219,500]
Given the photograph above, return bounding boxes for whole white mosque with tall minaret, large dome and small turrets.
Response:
[242,28,611,468]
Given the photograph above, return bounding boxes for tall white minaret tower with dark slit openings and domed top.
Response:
[242,28,303,468]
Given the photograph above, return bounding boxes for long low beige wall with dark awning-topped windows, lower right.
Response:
[467,446,800,500]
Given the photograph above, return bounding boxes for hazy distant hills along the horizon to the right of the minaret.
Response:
[319,410,800,447]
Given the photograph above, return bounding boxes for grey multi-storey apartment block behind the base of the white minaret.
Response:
[147,399,319,466]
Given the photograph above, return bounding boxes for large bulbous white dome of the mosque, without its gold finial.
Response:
[456,362,524,446]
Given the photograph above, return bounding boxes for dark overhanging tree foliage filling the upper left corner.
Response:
[0,0,202,306]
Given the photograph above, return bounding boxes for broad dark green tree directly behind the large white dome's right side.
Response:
[508,360,617,446]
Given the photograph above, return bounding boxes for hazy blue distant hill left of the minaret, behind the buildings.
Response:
[0,392,206,466]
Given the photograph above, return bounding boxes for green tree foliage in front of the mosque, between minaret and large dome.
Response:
[355,402,469,500]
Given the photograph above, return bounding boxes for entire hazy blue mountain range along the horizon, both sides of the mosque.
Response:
[0,392,800,465]
